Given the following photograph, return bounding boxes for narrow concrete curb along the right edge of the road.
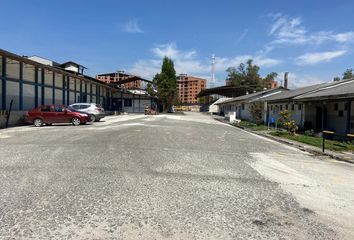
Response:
[215,119,354,164]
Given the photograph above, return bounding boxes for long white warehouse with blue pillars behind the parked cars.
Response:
[0,49,152,128]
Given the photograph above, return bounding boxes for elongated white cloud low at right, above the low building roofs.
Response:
[295,50,346,65]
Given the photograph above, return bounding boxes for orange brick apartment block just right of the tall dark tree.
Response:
[177,74,206,104]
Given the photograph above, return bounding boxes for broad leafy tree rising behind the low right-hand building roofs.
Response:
[226,59,278,91]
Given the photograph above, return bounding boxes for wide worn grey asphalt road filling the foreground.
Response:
[0,113,354,239]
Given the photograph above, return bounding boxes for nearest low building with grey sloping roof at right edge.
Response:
[264,79,354,135]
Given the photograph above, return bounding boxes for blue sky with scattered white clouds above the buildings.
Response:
[0,0,354,88]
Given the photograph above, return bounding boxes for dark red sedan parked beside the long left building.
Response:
[26,105,90,127]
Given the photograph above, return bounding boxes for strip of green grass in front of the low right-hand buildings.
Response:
[269,131,354,151]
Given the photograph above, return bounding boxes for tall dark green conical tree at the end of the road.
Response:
[147,57,177,112]
